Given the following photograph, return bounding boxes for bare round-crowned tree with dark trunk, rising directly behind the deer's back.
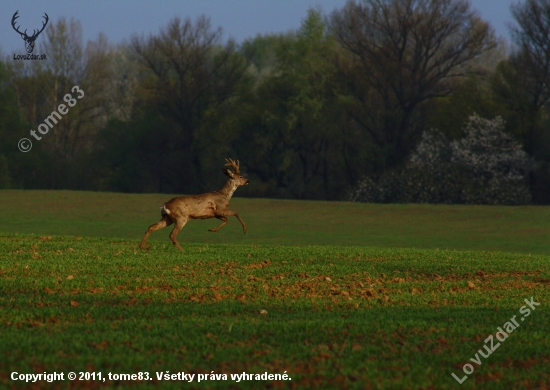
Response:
[131,16,245,189]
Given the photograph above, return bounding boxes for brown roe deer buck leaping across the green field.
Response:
[139,158,248,252]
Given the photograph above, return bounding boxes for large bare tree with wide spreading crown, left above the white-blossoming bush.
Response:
[331,0,495,166]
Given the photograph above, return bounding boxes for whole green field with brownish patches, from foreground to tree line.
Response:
[0,191,550,389]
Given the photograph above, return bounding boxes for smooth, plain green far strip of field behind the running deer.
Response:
[0,190,550,255]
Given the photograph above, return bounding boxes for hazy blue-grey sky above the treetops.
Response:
[0,0,517,55]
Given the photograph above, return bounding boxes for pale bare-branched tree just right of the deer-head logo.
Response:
[42,18,111,158]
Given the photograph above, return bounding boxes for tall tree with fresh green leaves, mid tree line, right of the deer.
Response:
[227,9,349,199]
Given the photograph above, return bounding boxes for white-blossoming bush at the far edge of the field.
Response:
[351,115,533,205]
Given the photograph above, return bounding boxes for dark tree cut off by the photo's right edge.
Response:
[493,0,550,203]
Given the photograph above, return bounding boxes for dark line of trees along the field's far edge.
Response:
[0,0,550,204]
